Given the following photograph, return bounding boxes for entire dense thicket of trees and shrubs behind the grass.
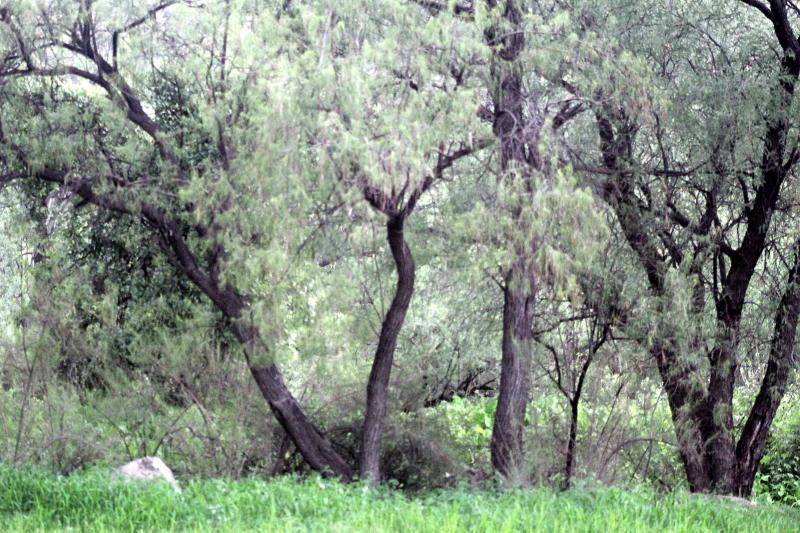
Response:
[0,0,800,495]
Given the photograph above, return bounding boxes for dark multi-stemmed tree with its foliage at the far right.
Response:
[560,0,799,495]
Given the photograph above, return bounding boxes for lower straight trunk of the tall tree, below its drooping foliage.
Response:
[491,266,536,480]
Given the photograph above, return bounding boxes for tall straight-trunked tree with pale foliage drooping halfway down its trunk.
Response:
[487,1,604,479]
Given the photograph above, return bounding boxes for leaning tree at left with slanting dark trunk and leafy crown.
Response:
[2,2,351,478]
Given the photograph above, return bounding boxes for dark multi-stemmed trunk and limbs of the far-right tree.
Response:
[596,0,800,496]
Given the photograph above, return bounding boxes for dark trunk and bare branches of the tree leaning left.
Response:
[2,11,351,479]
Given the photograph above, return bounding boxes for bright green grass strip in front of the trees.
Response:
[0,467,800,533]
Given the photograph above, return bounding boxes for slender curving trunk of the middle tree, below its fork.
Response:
[359,214,415,485]
